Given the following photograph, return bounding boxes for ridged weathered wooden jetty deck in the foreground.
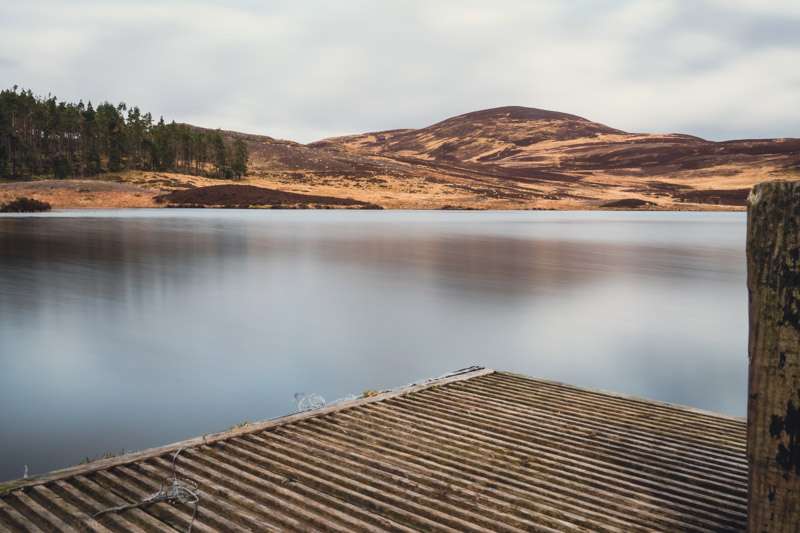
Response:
[0,369,747,532]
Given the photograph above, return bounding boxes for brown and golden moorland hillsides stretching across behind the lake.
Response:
[0,107,800,210]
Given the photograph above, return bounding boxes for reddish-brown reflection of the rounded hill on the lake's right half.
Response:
[315,236,743,297]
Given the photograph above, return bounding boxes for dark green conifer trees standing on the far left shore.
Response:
[0,86,248,179]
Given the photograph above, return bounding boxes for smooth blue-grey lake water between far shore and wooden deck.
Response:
[0,210,747,479]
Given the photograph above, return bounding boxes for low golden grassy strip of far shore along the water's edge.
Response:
[0,171,749,212]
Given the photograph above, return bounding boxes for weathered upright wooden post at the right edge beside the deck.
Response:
[747,181,800,533]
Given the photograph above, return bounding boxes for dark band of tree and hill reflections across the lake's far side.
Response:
[0,212,743,306]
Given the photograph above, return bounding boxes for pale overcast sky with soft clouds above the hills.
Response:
[0,0,800,142]
